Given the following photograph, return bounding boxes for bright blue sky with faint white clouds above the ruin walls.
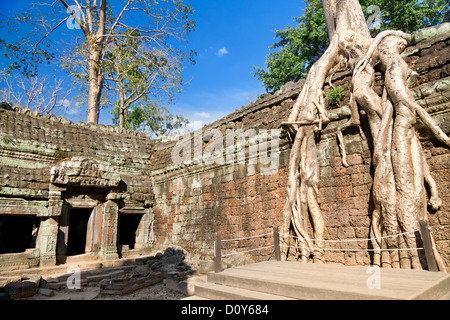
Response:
[0,0,305,127]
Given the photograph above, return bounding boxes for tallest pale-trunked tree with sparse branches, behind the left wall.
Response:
[0,0,195,124]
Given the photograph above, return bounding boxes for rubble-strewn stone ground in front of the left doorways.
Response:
[0,248,195,300]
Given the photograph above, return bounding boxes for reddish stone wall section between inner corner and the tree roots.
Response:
[151,91,298,257]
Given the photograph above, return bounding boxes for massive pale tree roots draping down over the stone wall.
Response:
[282,0,450,271]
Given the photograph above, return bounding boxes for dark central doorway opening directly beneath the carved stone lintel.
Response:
[66,209,92,256]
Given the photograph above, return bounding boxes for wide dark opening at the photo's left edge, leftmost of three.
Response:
[0,216,40,254]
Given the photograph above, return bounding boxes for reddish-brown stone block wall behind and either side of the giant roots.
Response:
[151,25,450,265]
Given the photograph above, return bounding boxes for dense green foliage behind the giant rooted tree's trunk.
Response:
[253,0,448,93]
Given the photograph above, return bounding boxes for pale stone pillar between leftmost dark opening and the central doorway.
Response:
[36,217,59,267]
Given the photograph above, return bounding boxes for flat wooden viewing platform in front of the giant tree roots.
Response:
[188,261,450,300]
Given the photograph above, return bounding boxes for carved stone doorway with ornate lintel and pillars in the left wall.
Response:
[50,157,155,265]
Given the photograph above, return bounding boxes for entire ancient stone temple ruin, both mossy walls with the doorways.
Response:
[0,24,450,272]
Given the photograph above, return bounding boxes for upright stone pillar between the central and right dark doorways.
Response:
[101,200,119,259]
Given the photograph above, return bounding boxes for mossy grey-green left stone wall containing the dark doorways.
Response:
[0,108,154,270]
